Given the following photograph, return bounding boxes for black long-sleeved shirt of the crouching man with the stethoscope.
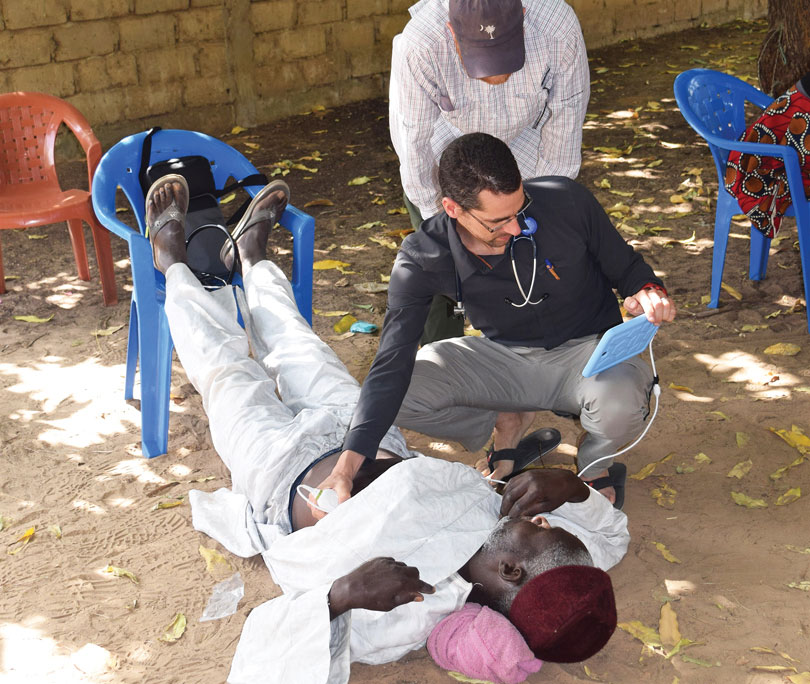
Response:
[343,176,662,458]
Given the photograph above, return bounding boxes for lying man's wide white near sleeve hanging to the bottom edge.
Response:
[228,583,351,684]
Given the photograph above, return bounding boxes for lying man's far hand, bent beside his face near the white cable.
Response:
[501,468,591,518]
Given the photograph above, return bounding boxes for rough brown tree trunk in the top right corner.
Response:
[757,0,810,97]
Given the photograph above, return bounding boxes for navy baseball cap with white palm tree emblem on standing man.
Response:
[450,0,526,78]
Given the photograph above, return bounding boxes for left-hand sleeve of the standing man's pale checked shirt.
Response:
[388,34,441,219]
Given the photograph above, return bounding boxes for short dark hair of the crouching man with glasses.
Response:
[439,133,520,209]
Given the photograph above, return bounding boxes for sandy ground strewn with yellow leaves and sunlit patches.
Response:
[0,14,810,684]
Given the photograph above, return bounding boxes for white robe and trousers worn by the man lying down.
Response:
[166,262,629,684]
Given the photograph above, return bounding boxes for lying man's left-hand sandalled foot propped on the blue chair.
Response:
[146,181,188,273]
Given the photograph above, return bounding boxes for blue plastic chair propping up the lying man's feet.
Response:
[92,130,315,458]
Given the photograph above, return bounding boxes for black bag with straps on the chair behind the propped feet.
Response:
[138,126,267,287]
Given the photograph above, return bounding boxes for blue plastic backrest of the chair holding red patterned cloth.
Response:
[674,69,773,179]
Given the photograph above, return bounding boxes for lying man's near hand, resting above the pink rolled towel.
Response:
[329,558,436,619]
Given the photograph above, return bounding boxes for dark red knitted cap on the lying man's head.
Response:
[509,565,616,663]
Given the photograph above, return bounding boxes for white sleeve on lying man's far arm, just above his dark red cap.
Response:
[545,489,630,570]
